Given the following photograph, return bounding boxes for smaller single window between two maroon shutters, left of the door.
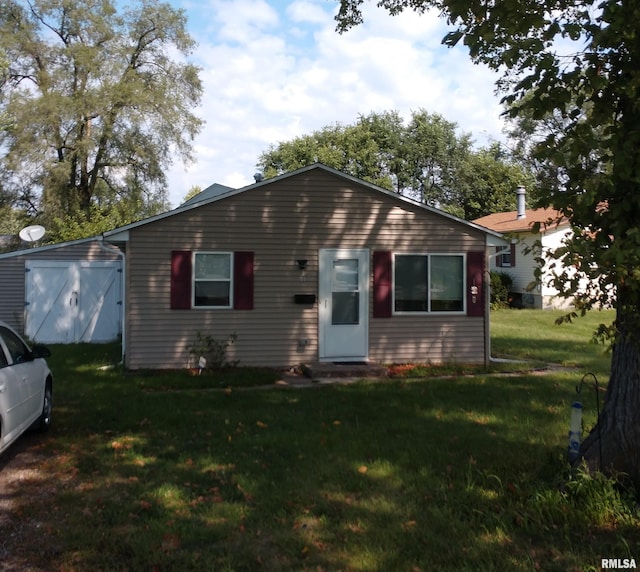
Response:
[193,252,233,308]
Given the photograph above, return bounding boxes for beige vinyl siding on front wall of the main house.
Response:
[125,170,484,369]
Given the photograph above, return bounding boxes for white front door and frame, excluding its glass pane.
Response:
[318,248,370,362]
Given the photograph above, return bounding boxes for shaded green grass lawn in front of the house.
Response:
[15,312,640,571]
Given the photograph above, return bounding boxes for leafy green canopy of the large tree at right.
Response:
[337,0,640,314]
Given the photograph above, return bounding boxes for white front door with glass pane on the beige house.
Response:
[319,249,369,361]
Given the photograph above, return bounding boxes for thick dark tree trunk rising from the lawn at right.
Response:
[580,287,640,493]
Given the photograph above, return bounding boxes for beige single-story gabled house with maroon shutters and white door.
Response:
[104,164,506,369]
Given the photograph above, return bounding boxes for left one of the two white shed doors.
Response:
[24,260,79,344]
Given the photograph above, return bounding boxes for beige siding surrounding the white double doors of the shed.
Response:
[0,240,119,334]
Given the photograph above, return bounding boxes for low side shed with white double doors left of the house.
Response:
[0,237,122,343]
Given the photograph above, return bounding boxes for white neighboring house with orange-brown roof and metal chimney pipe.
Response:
[473,187,571,309]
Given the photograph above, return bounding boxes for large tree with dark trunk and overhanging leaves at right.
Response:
[337,0,640,490]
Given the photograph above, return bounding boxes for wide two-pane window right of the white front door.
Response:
[394,254,465,313]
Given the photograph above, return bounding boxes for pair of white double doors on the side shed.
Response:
[25,260,122,343]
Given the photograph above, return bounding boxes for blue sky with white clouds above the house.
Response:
[162,0,504,207]
